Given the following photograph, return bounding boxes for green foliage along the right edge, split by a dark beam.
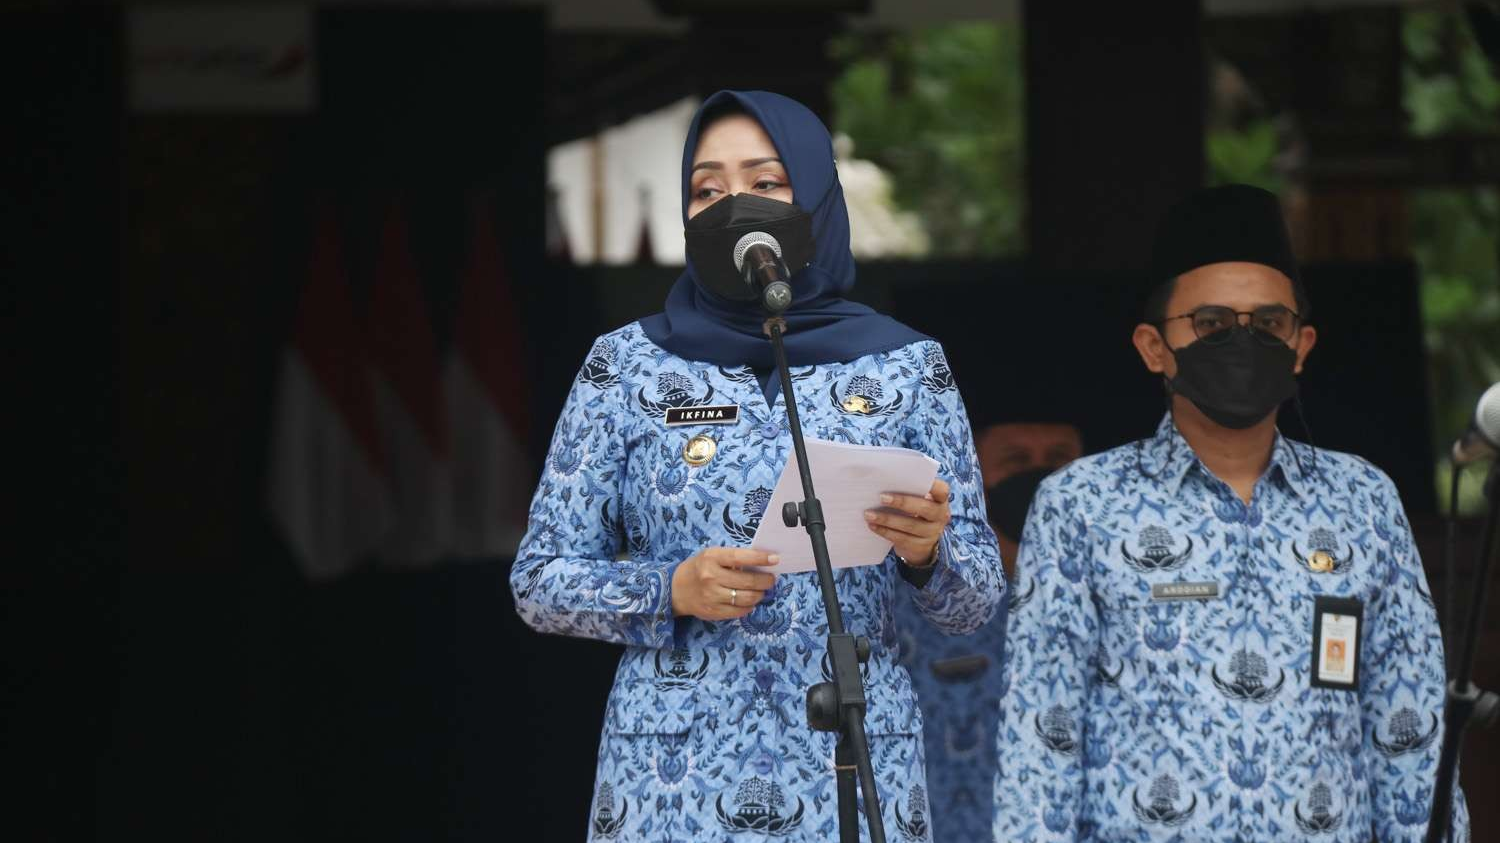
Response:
[1403,11,1500,513]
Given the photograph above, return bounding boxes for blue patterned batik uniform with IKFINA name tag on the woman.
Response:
[512,318,1005,842]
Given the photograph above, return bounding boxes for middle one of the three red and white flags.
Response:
[369,201,453,567]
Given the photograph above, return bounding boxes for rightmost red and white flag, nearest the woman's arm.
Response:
[446,201,536,557]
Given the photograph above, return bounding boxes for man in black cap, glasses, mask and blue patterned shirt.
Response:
[995,185,1469,843]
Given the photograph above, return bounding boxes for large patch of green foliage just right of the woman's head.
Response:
[833,23,1026,257]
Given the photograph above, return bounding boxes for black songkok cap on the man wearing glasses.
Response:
[1151,185,1302,282]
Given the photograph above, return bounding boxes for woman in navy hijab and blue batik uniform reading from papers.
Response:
[512,92,1004,842]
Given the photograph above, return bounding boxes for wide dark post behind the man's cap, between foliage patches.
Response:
[1025,0,1205,276]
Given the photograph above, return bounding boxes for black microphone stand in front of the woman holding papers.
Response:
[764,293,885,843]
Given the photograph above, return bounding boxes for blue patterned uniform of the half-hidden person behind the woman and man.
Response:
[896,564,1014,843]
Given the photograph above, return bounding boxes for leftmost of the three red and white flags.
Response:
[267,213,392,581]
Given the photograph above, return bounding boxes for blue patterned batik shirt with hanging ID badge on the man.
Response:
[995,416,1469,843]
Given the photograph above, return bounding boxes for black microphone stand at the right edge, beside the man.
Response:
[1427,459,1500,843]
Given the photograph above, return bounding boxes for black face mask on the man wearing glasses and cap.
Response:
[1167,326,1298,431]
